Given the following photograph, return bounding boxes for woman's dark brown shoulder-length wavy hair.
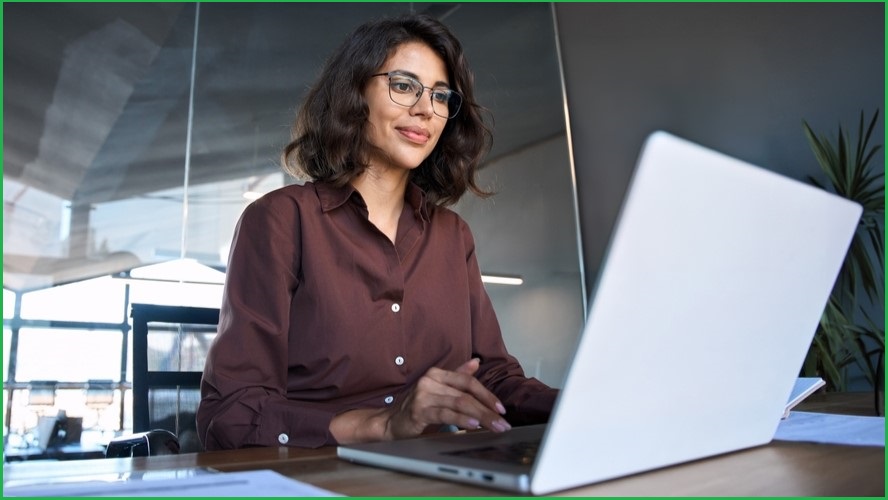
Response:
[281,15,491,206]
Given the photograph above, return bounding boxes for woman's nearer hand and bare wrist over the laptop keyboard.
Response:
[330,358,511,444]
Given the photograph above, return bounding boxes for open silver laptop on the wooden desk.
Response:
[338,132,861,494]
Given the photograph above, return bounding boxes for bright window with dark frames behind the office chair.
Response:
[3,276,224,448]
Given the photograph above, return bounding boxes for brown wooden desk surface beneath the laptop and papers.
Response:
[3,394,885,497]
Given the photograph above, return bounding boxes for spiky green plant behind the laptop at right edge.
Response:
[802,109,885,402]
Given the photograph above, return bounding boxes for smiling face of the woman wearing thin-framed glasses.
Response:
[364,42,450,176]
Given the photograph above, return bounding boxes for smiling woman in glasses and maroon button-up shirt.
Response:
[197,12,556,450]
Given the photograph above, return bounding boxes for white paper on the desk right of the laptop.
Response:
[774,411,885,447]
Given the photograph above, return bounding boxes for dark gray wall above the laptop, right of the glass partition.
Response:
[555,3,885,286]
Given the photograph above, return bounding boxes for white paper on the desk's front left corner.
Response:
[3,470,339,497]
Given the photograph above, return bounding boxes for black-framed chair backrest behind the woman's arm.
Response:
[131,304,219,453]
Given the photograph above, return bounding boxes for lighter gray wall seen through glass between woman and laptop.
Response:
[456,134,585,387]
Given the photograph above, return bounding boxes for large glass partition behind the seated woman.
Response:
[3,2,585,442]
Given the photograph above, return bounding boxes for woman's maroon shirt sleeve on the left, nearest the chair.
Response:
[197,189,340,449]
